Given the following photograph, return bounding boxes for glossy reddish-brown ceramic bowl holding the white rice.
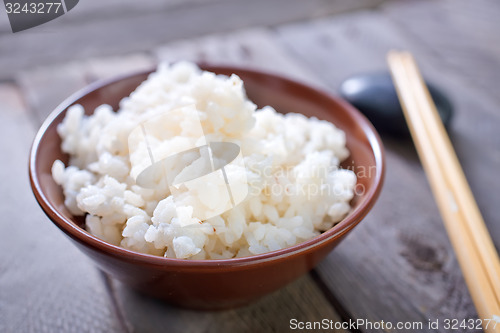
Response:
[29,66,384,309]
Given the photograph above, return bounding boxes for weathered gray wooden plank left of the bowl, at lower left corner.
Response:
[0,84,121,333]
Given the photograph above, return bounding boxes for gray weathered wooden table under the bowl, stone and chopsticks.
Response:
[0,0,500,332]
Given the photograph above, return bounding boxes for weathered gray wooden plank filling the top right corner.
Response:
[384,0,500,102]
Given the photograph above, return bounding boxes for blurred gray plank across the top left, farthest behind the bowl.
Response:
[0,0,384,79]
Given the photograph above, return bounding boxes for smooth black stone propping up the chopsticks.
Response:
[339,72,453,137]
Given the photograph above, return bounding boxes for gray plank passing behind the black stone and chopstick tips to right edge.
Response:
[280,12,500,246]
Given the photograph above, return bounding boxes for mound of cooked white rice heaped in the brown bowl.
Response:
[52,62,356,259]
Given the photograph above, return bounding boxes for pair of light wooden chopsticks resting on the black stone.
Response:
[387,51,500,333]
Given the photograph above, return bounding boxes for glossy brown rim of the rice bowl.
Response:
[28,63,386,268]
